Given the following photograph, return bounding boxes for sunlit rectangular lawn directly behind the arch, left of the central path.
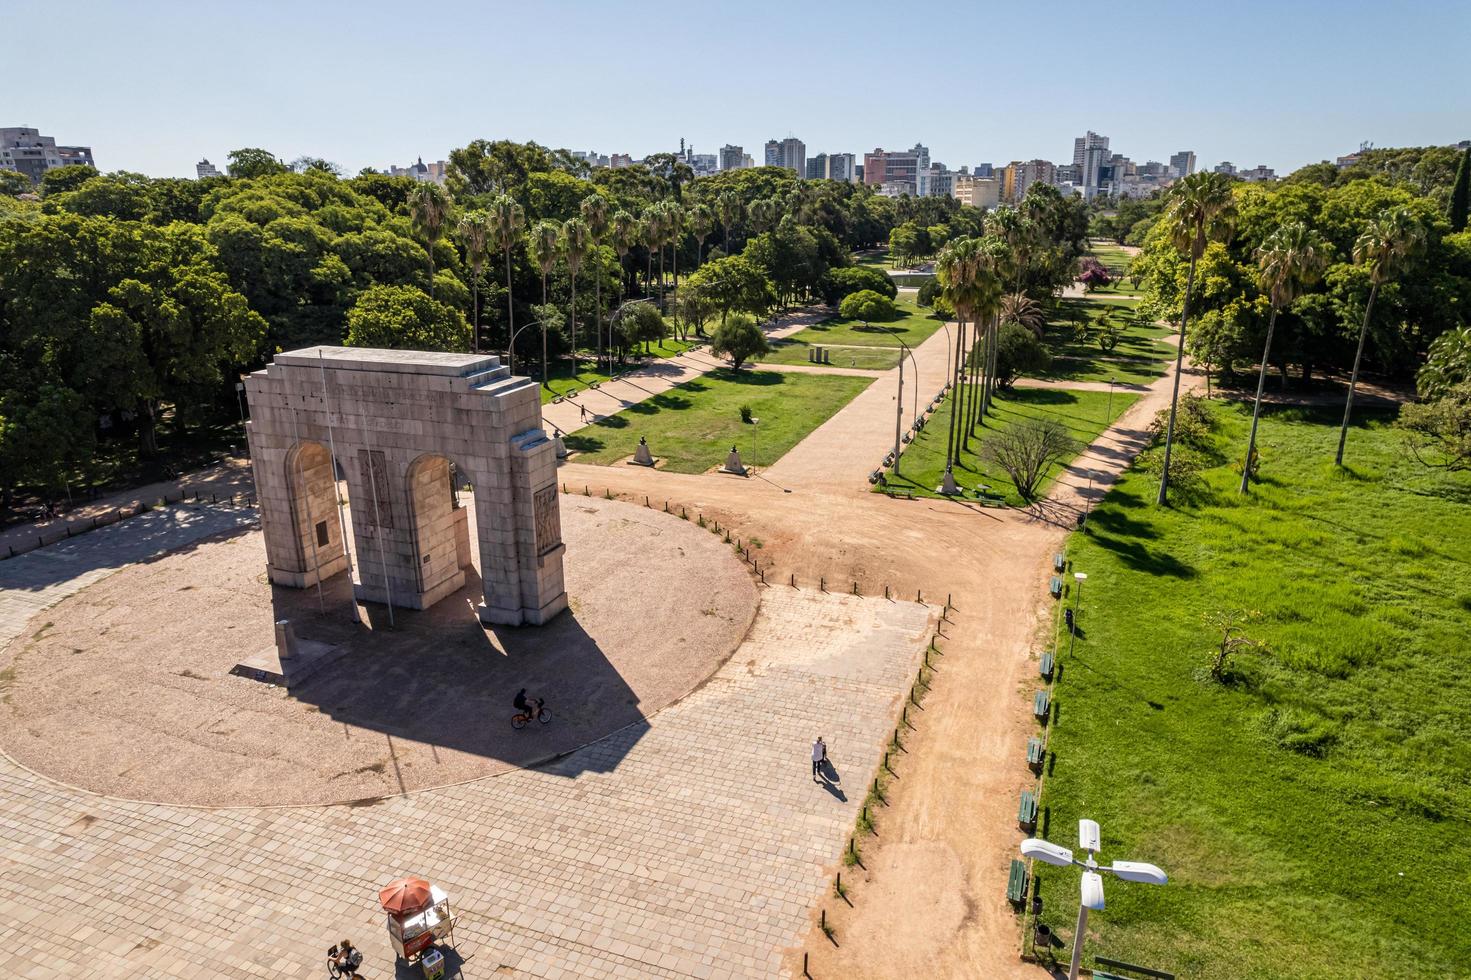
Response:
[566,368,872,472]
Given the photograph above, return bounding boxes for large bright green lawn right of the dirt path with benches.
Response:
[1035,406,1471,980]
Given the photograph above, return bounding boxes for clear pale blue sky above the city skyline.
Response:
[11,0,1471,177]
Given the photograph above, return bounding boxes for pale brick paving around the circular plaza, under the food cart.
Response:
[0,535,931,979]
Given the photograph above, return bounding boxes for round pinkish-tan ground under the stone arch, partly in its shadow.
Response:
[0,496,759,805]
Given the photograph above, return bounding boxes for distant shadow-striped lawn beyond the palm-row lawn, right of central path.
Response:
[1040,296,1175,384]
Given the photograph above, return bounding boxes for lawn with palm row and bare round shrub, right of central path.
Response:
[888,388,1139,505]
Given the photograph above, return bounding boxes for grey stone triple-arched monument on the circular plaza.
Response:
[246,347,566,625]
